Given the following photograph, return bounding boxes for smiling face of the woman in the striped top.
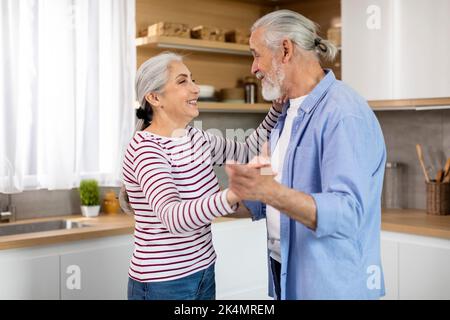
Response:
[158,61,200,124]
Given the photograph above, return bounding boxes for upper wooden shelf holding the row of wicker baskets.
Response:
[136,36,251,56]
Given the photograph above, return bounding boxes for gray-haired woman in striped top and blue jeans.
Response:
[123,53,281,300]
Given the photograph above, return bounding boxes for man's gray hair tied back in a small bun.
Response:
[251,10,337,61]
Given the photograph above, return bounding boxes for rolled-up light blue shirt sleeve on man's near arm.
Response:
[311,116,376,237]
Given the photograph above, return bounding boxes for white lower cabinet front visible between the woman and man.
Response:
[212,219,271,300]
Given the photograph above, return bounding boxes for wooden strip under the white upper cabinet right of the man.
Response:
[369,97,450,111]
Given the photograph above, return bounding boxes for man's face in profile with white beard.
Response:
[250,28,285,101]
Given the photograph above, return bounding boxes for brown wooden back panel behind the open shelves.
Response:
[136,0,270,90]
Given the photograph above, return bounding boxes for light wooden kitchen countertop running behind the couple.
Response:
[0,209,450,250]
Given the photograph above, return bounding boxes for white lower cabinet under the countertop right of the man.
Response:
[381,231,450,300]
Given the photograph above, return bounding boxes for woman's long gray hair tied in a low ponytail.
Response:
[119,51,183,214]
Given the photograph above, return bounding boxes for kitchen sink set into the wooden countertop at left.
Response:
[0,220,89,237]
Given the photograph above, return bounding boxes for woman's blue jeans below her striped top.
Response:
[128,264,216,300]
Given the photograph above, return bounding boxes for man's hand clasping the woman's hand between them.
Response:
[225,157,278,202]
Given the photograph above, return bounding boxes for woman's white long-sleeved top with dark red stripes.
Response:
[123,108,279,282]
